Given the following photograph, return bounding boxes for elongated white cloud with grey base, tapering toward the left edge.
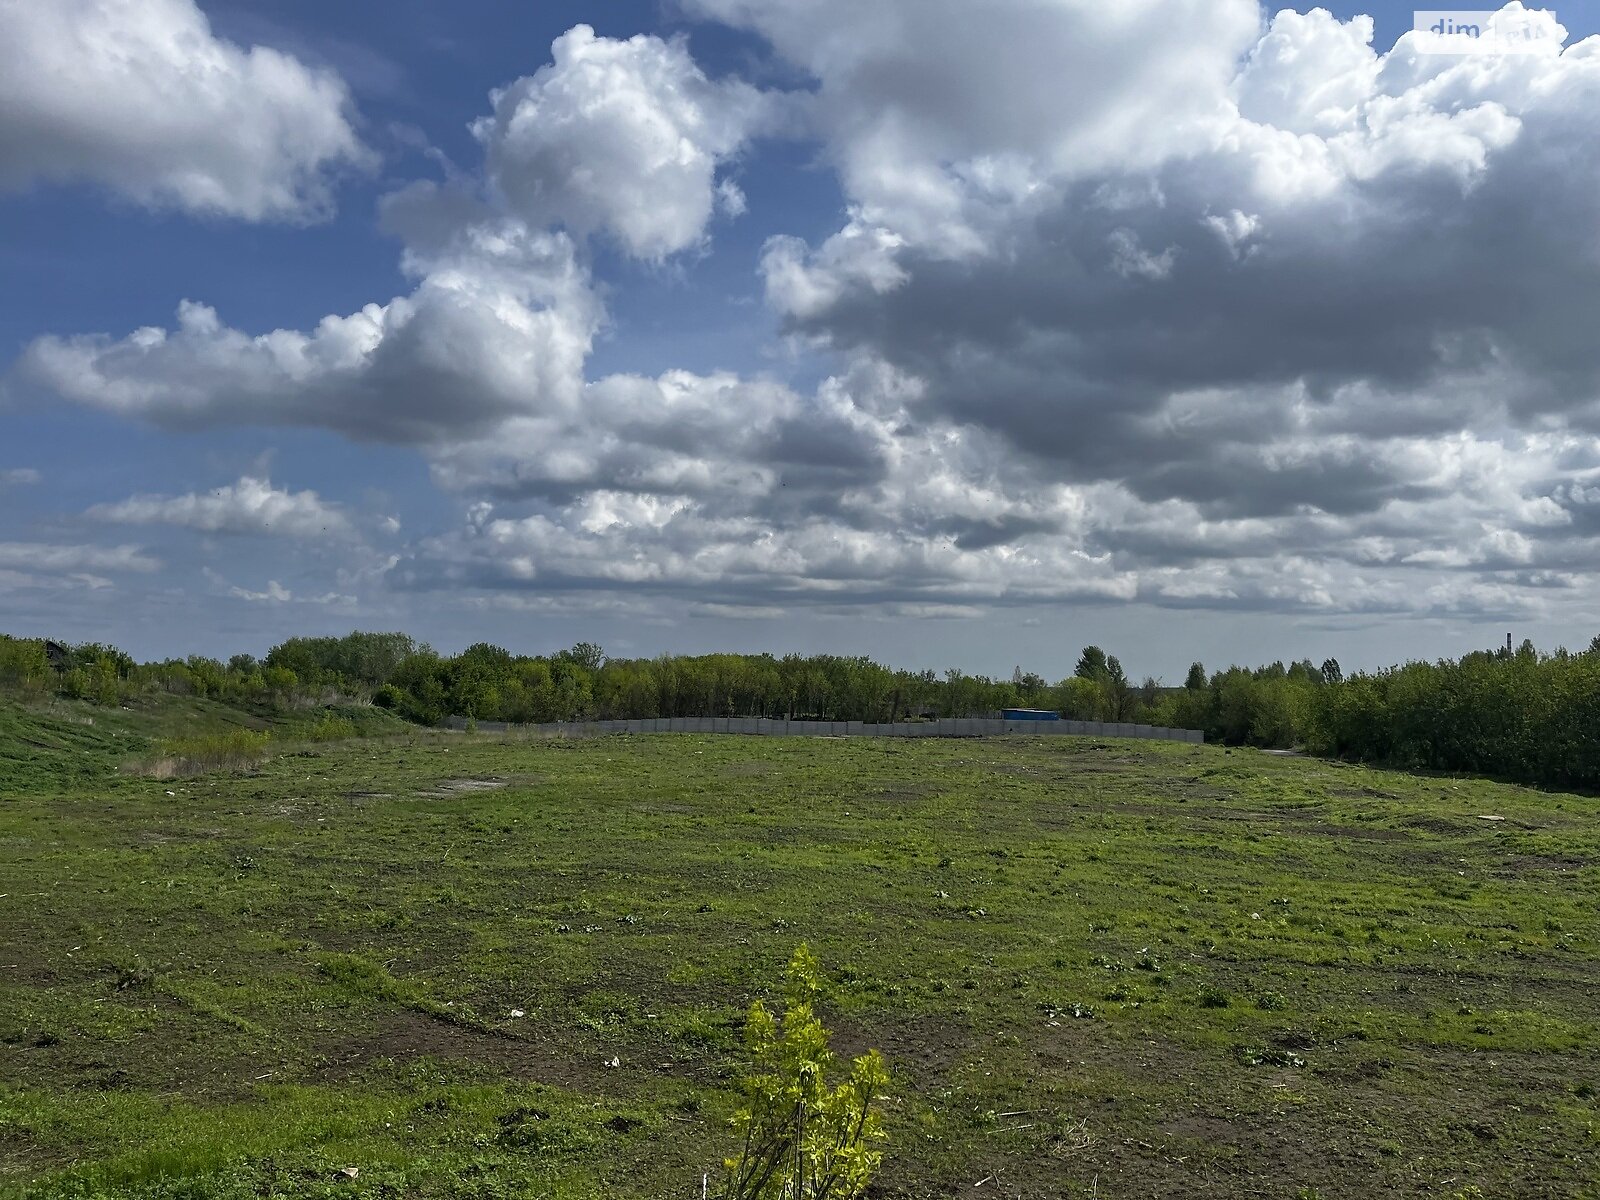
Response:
[14,214,602,442]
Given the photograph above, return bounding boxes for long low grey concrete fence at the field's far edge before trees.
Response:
[446,717,1205,742]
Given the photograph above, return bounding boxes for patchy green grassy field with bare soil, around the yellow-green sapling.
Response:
[0,704,1600,1200]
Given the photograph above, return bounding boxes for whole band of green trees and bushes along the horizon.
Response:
[0,632,1600,789]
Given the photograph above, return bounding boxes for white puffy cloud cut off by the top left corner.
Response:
[0,0,371,221]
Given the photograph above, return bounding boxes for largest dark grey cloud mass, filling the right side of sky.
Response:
[755,5,1600,531]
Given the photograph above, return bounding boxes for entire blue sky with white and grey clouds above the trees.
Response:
[0,0,1600,680]
